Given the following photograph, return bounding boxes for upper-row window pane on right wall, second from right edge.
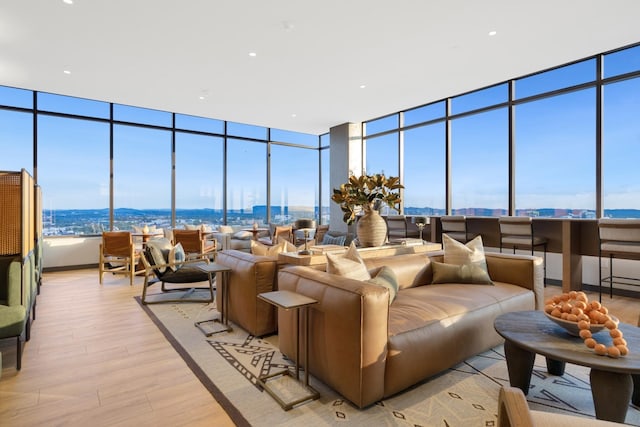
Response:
[515,59,596,99]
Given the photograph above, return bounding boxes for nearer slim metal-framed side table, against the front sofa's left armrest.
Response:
[258,291,320,411]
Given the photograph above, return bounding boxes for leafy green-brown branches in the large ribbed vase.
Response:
[331,174,404,225]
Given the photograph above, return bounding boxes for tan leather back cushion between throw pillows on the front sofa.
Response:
[364,254,432,289]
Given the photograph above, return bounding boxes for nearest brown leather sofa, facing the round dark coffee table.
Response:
[278,253,544,408]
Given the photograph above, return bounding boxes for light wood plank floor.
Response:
[0,270,640,426]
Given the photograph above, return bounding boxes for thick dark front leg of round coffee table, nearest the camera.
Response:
[589,369,633,423]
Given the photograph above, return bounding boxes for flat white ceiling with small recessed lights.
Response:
[0,0,640,134]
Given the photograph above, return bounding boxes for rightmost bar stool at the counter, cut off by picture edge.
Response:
[598,218,640,301]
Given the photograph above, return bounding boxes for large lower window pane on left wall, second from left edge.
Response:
[38,115,109,235]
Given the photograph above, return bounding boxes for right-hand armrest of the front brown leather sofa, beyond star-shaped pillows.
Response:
[485,252,544,310]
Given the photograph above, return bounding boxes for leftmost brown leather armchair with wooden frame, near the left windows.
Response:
[98,231,140,286]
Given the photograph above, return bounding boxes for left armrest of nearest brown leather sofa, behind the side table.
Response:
[278,267,389,408]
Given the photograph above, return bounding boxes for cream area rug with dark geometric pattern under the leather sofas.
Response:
[142,303,640,427]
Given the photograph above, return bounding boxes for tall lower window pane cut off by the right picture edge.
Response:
[602,78,640,218]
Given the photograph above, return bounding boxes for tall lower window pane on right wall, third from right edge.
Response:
[451,108,509,216]
